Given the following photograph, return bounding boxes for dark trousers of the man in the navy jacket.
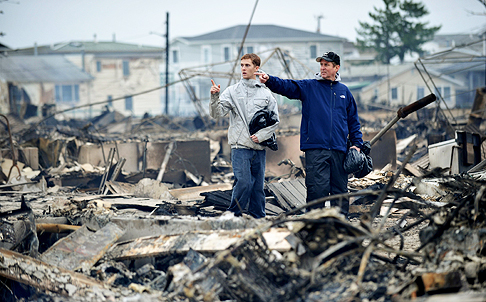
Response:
[305,149,349,215]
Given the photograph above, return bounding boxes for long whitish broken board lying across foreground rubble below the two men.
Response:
[106,228,291,260]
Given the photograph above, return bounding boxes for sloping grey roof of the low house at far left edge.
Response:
[0,56,92,83]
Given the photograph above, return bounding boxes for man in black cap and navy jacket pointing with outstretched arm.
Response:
[257,51,363,216]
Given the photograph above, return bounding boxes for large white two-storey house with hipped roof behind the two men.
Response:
[162,25,346,115]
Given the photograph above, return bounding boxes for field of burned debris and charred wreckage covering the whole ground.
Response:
[0,86,486,301]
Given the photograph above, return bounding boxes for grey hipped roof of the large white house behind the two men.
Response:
[181,25,346,43]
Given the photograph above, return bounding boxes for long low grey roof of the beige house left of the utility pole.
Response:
[8,41,164,57]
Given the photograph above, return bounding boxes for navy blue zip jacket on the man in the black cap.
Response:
[265,75,363,152]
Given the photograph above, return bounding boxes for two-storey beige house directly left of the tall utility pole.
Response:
[7,41,163,118]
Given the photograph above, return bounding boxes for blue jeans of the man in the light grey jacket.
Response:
[228,149,265,218]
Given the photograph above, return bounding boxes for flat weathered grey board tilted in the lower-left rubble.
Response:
[40,223,125,271]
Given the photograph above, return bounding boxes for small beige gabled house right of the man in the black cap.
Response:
[359,65,465,108]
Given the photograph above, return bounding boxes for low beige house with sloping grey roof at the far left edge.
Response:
[0,55,92,118]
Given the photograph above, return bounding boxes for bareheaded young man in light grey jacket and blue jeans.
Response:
[209,54,278,218]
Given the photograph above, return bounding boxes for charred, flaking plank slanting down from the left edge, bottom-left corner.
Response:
[0,248,106,296]
